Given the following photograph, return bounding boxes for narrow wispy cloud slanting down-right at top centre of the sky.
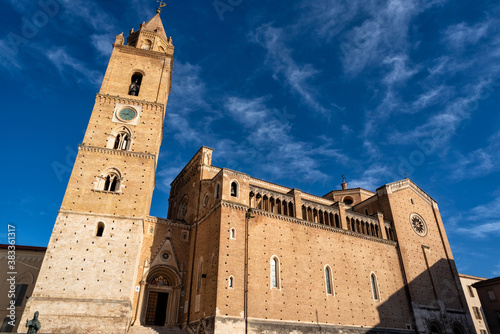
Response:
[252,24,327,112]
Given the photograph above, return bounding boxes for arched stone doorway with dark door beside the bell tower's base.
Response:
[141,266,181,326]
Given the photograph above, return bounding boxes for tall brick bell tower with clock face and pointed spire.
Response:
[20,7,174,333]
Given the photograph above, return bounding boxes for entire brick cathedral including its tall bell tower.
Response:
[20,8,474,334]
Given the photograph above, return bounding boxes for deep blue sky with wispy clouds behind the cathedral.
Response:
[0,0,500,277]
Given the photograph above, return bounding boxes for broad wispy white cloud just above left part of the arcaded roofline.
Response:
[223,97,350,182]
